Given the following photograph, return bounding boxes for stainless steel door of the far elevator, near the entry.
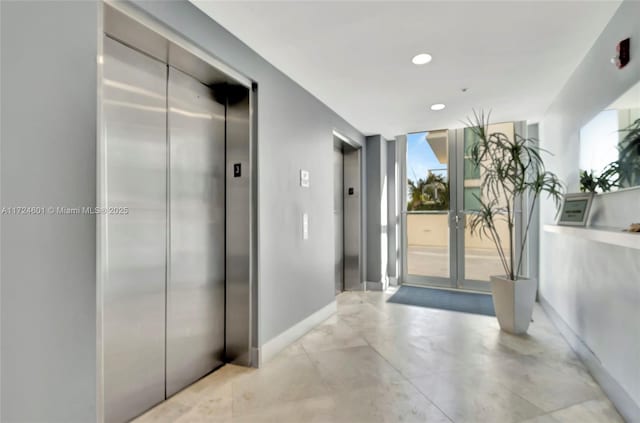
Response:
[333,147,344,294]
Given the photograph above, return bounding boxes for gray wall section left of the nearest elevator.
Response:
[0,1,98,422]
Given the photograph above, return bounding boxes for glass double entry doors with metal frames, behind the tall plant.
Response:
[398,122,519,291]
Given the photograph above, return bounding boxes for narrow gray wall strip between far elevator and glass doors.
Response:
[365,135,387,289]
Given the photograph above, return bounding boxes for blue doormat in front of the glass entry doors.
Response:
[387,286,496,316]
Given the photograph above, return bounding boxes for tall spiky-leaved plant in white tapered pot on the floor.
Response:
[467,111,562,334]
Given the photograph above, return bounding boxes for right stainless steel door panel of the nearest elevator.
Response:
[166,67,225,396]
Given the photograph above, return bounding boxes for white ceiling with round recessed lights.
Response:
[192,0,620,138]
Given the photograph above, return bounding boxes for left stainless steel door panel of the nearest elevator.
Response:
[103,37,167,422]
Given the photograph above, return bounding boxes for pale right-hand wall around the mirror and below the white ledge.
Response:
[540,1,640,419]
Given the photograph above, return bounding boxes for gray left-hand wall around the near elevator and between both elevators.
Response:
[1,1,366,422]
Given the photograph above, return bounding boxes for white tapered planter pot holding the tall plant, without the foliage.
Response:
[491,276,537,335]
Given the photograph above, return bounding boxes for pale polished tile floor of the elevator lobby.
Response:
[137,292,623,423]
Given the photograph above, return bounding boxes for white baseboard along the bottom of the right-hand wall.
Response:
[540,295,640,423]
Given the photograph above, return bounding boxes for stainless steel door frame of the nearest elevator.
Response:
[96,0,258,421]
